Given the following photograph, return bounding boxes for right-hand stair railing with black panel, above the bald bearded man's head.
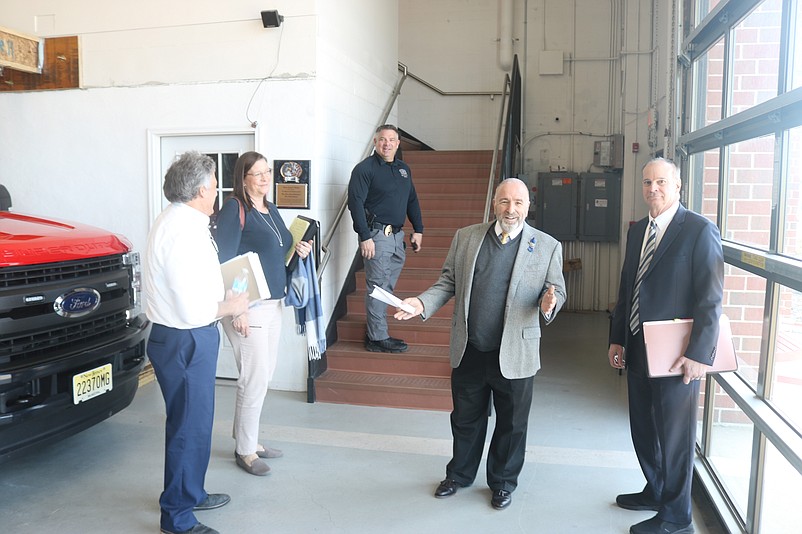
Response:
[483,55,522,222]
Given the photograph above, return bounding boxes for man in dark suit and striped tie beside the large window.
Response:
[608,158,724,534]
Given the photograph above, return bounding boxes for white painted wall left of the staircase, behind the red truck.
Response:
[0,0,398,391]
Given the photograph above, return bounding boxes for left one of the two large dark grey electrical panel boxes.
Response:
[535,172,578,241]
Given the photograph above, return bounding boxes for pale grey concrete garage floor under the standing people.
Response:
[0,313,723,534]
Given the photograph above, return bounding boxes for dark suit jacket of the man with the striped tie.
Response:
[610,205,724,365]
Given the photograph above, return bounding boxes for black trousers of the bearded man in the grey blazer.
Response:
[446,344,534,491]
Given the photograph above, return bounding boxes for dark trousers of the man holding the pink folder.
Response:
[627,333,700,523]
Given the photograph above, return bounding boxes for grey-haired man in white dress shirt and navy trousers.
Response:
[143,152,248,534]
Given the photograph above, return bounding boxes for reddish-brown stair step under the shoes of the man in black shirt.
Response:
[326,341,451,378]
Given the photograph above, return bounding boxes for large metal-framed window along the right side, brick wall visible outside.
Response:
[677,0,802,534]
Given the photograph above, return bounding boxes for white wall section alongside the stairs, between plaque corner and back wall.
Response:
[314,0,398,336]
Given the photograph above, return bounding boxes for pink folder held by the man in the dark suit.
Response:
[643,314,738,378]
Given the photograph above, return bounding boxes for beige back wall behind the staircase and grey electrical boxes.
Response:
[399,0,671,310]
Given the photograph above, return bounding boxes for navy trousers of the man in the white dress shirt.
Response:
[147,324,220,532]
